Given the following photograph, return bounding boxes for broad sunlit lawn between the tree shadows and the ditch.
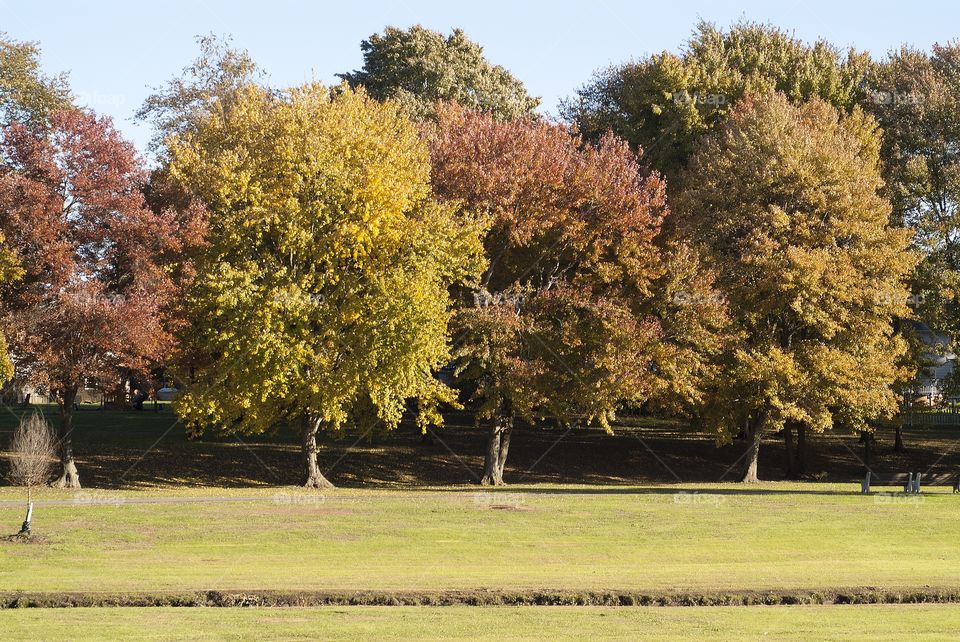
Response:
[0,483,960,593]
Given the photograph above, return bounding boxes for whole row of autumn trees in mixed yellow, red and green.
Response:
[0,23,948,487]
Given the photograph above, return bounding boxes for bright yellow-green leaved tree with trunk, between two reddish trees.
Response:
[168,84,483,487]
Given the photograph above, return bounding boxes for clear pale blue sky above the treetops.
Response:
[0,0,960,155]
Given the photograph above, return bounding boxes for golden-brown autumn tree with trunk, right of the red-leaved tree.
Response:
[679,93,916,481]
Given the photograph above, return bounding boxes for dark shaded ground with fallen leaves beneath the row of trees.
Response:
[0,407,960,495]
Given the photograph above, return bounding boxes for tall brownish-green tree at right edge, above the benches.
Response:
[864,43,960,400]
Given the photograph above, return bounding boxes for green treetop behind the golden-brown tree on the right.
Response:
[562,21,870,180]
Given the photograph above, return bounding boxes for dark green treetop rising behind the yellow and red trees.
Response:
[340,25,540,119]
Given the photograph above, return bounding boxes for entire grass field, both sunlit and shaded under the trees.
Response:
[0,408,960,640]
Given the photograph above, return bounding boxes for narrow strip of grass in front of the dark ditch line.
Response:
[0,605,960,642]
